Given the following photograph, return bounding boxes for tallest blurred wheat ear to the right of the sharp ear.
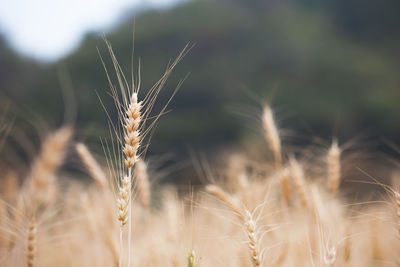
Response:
[262,105,282,170]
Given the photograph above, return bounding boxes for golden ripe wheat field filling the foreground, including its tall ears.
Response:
[0,41,400,267]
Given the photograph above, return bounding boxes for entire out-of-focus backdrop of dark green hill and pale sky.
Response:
[0,0,400,178]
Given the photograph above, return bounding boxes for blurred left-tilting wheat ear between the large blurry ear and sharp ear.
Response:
[75,143,108,188]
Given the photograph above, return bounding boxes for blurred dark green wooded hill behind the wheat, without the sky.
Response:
[3,0,400,157]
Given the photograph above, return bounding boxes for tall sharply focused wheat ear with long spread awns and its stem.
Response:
[100,39,188,267]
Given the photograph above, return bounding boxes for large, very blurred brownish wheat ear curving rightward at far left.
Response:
[28,126,72,209]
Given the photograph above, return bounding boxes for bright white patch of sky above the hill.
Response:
[0,0,179,61]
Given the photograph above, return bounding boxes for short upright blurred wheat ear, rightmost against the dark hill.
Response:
[327,141,341,194]
